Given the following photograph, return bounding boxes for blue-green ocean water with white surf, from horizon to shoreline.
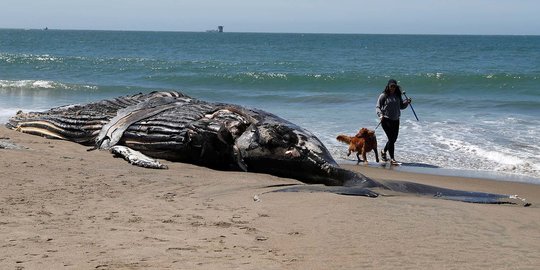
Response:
[0,29,540,184]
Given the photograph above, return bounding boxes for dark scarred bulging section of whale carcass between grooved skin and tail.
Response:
[235,114,343,185]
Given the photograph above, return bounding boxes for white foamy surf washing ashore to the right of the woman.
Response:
[412,126,540,178]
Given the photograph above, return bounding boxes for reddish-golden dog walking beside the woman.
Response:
[336,128,379,164]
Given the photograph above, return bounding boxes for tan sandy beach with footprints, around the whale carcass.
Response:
[0,127,540,269]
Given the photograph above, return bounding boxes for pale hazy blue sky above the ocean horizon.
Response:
[0,0,540,35]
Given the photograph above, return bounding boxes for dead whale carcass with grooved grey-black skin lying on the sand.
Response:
[6,92,528,203]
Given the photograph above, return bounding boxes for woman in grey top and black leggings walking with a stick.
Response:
[375,79,412,165]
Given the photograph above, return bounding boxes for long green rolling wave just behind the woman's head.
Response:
[147,68,540,92]
